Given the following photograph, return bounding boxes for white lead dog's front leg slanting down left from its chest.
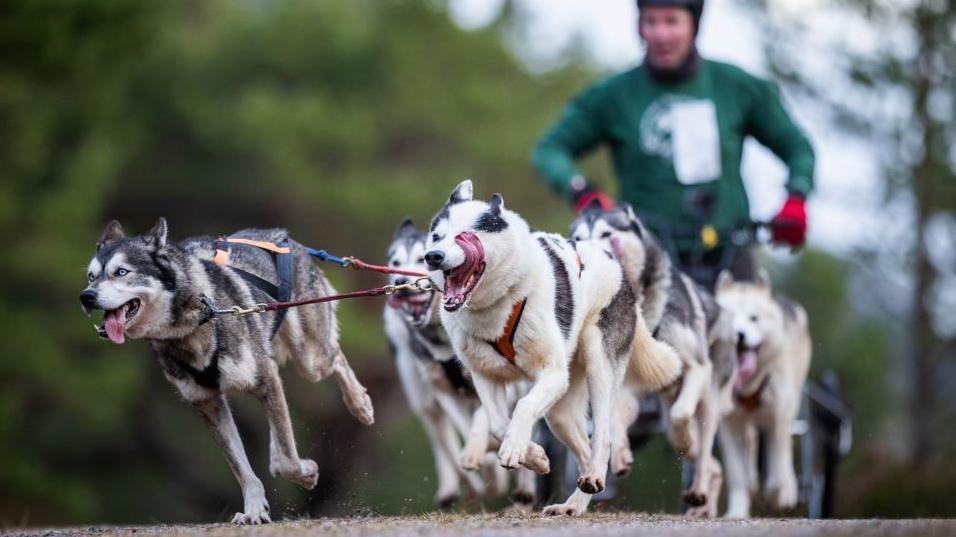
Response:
[498,364,568,474]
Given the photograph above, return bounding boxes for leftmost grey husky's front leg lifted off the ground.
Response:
[256,360,319,489]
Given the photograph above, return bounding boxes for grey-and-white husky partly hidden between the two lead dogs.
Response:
[385,219,535,507]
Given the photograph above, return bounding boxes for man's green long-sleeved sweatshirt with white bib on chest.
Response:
[532,60,814,241]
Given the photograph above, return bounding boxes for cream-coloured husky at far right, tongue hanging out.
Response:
[717,270,811,518]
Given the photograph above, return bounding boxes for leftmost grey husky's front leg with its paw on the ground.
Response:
[195,395,272,524]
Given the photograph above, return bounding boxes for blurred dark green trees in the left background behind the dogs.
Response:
[0,0,584,525]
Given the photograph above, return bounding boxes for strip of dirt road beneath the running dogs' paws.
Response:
[9,513,956,537]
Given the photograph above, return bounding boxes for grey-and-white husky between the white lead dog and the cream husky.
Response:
[571,204,736,516]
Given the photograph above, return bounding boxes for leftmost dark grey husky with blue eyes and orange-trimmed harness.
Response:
[80,218,373,524]
